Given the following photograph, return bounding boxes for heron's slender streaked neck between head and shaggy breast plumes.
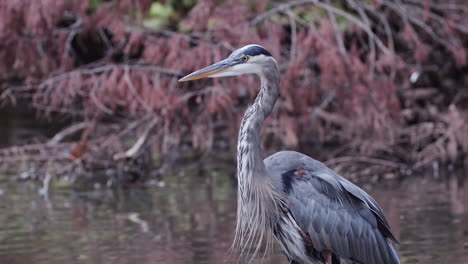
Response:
[237,64,280,187]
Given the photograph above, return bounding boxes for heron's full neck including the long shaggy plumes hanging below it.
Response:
[234,62,280,257]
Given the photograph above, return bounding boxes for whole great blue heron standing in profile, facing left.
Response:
[179,45,399,264]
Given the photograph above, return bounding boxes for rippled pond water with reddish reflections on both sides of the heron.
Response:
[0,168,468,264]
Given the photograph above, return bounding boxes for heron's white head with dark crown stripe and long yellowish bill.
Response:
[179,44,277,82]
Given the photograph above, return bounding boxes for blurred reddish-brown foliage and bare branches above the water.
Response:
[0,0,468,180]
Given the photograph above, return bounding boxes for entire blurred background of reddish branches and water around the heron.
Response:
[0,0,468,264]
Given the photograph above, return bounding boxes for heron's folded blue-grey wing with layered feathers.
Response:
[265,152,399,264]
